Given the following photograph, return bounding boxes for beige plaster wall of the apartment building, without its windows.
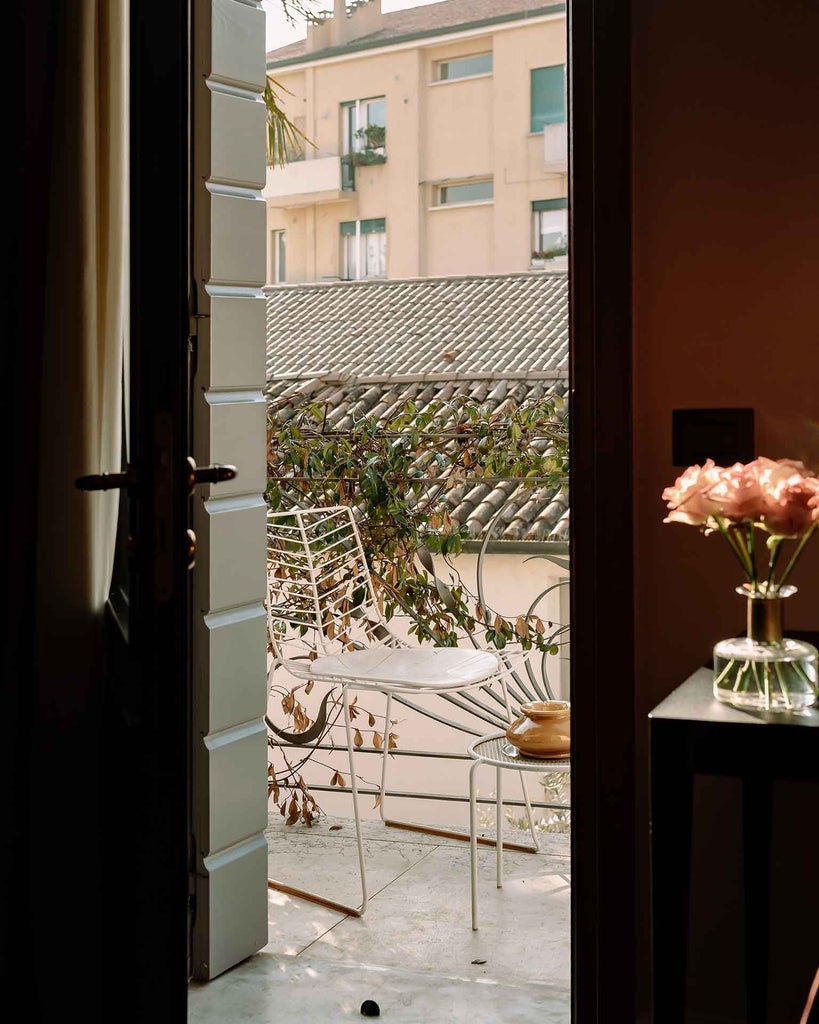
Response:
[267,15,567,283]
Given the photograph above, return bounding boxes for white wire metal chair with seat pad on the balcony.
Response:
[267,506,534,916]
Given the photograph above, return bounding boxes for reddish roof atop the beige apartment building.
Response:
[267,0,566,67]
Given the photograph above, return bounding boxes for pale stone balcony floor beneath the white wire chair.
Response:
[188,816,571,1024]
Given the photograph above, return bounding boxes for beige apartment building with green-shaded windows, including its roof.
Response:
[263,0,568,284]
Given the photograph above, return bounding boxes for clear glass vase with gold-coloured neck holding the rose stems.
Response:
[714,586,819,712]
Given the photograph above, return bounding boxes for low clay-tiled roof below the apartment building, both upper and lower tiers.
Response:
[266,271,569,542]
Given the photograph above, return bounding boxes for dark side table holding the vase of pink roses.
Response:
[648,655,819,1024]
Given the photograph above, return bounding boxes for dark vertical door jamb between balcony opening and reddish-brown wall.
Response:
[568,0,636,1024]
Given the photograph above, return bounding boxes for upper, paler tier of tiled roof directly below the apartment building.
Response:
[267,271,568,379]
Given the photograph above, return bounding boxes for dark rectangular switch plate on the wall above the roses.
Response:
[672,409,756,468]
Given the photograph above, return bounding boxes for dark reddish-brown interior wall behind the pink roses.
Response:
[632,0,819,1020]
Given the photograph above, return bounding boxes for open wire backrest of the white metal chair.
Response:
[267,505,391,660]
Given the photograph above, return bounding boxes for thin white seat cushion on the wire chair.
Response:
[299,647,500,691]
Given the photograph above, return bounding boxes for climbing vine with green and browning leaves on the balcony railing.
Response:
[266,396,568,824]
